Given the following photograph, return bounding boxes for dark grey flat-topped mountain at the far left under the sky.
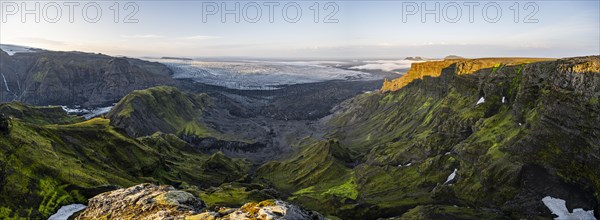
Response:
[0,51,172,107]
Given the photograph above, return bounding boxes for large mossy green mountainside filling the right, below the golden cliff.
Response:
[258,56,600,219]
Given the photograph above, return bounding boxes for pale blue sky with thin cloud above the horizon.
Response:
[0,0,600,59]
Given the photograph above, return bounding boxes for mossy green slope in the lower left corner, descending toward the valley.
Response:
[0,103,249,219]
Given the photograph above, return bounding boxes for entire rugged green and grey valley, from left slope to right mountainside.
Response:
[0,50,600,219]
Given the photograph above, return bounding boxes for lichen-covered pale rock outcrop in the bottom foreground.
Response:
[76,184,324,220]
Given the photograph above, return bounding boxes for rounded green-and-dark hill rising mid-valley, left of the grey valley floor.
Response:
[107,86,215,137]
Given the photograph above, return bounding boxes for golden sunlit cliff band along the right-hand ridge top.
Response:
[381,58,549,92]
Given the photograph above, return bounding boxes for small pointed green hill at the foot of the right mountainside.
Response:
[256,139,358,217]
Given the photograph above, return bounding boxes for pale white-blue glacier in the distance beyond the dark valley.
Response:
[150,59,374,90]
